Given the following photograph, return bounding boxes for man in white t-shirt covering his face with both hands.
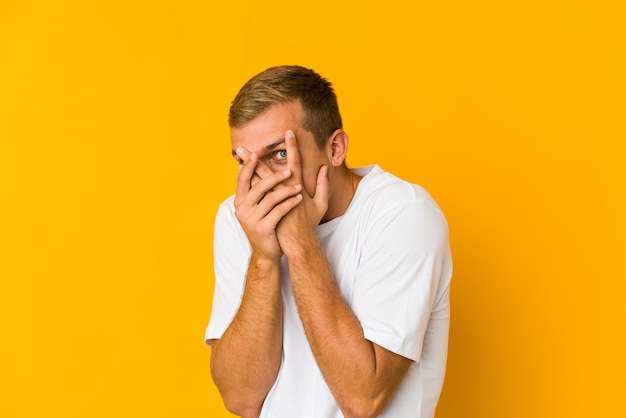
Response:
[206,66,452,418]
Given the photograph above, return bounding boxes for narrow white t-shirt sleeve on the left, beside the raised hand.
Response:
[205,199,250,344]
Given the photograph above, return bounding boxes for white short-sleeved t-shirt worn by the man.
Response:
[205,165,452,418]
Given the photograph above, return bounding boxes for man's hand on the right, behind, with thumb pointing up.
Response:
[277,131,329,257]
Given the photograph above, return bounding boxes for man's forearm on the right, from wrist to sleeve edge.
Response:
[288,242,408,417]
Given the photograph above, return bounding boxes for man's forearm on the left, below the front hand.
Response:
[211,254,282,417]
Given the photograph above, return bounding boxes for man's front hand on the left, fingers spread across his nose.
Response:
[235,148,302,260]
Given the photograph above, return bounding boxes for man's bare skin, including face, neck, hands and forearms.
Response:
[211,101,411,418]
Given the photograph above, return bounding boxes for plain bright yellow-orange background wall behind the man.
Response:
[0,0,626,418]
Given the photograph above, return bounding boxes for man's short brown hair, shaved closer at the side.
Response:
[228,65,343,148]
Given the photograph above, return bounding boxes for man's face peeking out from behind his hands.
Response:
[230,101,329,196]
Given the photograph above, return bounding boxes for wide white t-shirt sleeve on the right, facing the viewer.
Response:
[351,200,451,362]
